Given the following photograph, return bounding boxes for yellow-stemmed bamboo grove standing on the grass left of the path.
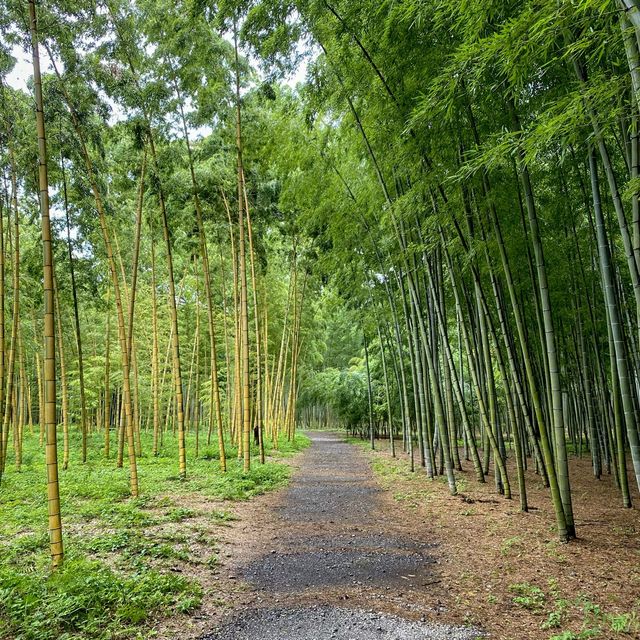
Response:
[0,2,306,567]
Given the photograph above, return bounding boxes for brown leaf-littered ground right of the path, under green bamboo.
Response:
[348,441,640,640]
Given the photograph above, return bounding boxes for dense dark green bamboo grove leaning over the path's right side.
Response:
[238,0,640,541]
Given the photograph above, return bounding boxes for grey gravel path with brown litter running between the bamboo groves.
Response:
[203,433,478,640]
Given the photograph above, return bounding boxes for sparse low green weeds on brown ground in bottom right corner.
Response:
[509,580,640,640]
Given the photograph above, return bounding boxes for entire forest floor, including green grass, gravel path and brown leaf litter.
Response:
[0,432,640,640]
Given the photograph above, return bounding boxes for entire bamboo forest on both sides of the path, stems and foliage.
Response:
[0,0,640,563]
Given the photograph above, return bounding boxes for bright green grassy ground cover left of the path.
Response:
[0,429,309,640]
